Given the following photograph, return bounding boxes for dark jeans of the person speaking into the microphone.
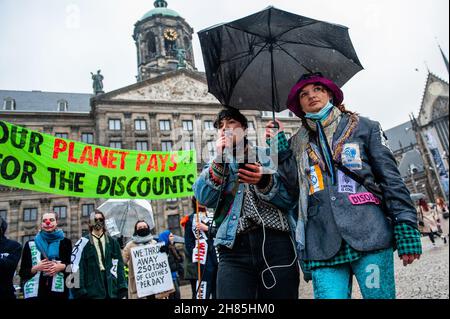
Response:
[217,228,300,299]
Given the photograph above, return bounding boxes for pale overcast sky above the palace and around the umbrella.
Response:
[0,0,449,129]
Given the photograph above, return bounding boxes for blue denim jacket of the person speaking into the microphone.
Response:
[193,147,297,248]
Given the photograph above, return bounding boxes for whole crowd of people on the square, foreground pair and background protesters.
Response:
[0,73,448,299]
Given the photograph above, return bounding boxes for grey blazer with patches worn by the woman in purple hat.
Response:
[279,114,417,260]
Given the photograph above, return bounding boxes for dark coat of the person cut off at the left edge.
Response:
[0,219,22,299]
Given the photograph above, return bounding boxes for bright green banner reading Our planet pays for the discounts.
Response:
[0,121,197,199]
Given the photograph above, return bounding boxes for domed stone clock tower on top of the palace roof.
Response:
[133,0,196,82]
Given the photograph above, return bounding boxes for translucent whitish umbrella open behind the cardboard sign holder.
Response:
[97,199,155,237]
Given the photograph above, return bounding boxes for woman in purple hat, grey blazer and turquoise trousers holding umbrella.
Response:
[267,73,422,299]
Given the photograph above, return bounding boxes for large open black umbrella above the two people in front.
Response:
[198,7,362,121]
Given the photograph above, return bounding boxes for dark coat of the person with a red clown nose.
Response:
[19,238,72,299]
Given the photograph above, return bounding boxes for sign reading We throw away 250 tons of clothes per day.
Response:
[131,243,174,298]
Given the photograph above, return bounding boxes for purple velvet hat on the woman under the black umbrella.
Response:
[287,73,344,117]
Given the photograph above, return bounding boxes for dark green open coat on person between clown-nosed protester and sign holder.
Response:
[73,234,128,299]
